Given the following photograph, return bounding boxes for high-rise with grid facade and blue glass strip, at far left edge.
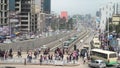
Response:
[0,0,15,26]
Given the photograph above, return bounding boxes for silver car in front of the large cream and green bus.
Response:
[88,60,106,68]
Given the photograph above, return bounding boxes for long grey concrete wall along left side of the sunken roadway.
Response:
[0,30,75,51]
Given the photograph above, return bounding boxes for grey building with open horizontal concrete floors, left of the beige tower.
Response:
[15,0,35,33]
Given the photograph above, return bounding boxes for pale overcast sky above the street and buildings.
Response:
[37,0,120,15]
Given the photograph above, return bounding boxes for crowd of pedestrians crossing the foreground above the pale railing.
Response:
[0,48,90,64]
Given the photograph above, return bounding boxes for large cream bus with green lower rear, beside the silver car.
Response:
[90,49,117,65]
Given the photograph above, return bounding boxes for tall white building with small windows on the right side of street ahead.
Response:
[99,2,114,33]
